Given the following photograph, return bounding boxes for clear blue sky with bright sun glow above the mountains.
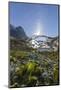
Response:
[9,2,58,37]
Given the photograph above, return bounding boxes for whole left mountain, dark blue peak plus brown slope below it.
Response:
[10,24,29,50]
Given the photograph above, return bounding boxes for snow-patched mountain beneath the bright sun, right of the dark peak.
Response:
[29,35,59,51]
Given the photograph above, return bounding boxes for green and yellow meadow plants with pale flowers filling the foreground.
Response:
[10,50,59,87]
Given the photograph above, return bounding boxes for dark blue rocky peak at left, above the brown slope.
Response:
[10,24,27,40]
